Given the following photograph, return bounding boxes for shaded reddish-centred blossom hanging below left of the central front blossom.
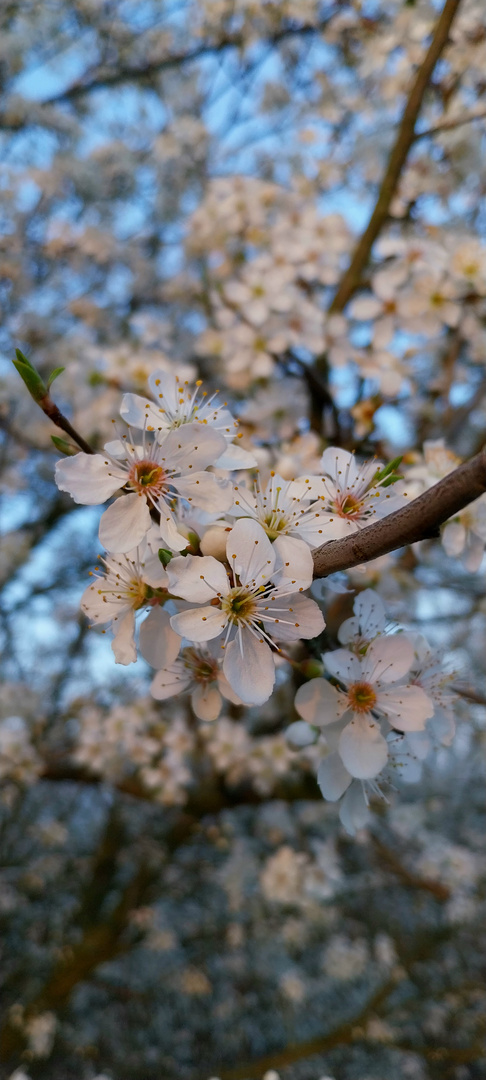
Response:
[149,643,241,720]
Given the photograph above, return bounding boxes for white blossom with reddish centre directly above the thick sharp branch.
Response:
[293,446,406,541]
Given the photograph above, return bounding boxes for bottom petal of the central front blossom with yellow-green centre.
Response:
[222,630,275,705]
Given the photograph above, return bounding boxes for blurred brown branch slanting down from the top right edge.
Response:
[329,0,460,313]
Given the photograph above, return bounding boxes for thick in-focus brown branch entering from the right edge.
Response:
[313,450,486,578]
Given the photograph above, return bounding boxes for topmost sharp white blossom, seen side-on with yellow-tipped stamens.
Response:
[120,369,257,470]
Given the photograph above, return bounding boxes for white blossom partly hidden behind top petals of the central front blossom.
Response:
[231,472,330,548]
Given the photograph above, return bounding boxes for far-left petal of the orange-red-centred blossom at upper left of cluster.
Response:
[55,454,126,507]
